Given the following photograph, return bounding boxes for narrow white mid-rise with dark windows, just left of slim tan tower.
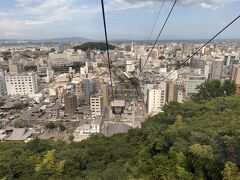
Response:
[90,95,103,118]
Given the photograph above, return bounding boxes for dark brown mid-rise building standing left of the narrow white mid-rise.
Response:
[64,91,78,114]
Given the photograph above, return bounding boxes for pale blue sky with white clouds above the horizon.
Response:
[0,0,240,40]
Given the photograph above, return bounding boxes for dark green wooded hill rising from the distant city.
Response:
[73,42,116,51]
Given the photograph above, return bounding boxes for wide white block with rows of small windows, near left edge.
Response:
[5,73,38,95]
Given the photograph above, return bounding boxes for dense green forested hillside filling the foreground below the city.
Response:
[0,96,240,180]
